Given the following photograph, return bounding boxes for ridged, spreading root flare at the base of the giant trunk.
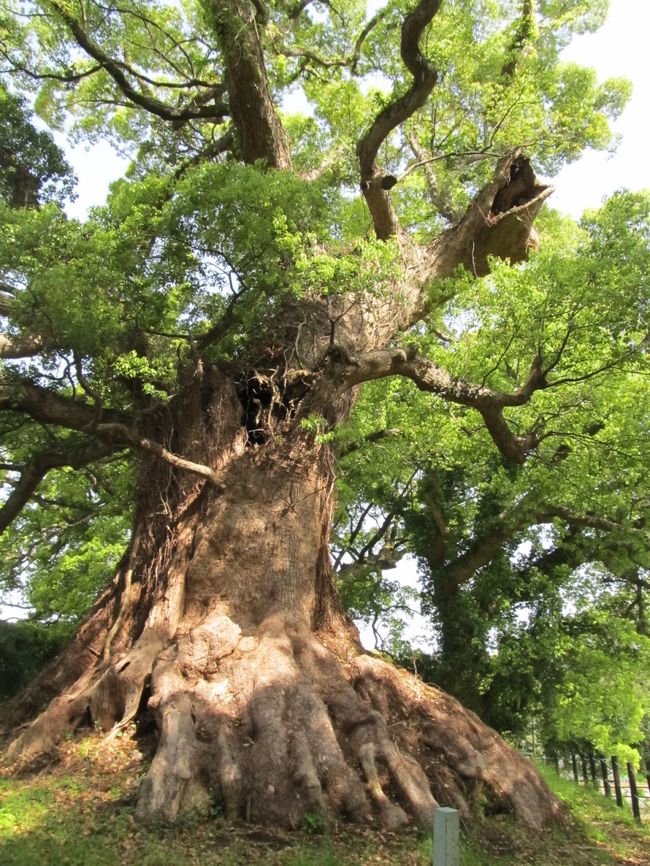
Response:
[1,614,561,830]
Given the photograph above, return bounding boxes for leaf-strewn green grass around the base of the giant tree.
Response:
[0,736,650,866]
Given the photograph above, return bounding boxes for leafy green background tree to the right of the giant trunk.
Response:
[335,194,648,743]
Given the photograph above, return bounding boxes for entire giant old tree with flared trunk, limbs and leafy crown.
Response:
[0,0,626,828]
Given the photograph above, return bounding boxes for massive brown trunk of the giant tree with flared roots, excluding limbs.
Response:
[0,371,559,829]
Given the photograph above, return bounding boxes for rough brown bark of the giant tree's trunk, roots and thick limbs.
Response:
[0,0,561,829]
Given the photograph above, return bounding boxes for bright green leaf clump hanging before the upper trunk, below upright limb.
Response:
[161,164,395,352]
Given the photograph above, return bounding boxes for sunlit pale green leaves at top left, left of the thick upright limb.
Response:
[10,0,219,146]
